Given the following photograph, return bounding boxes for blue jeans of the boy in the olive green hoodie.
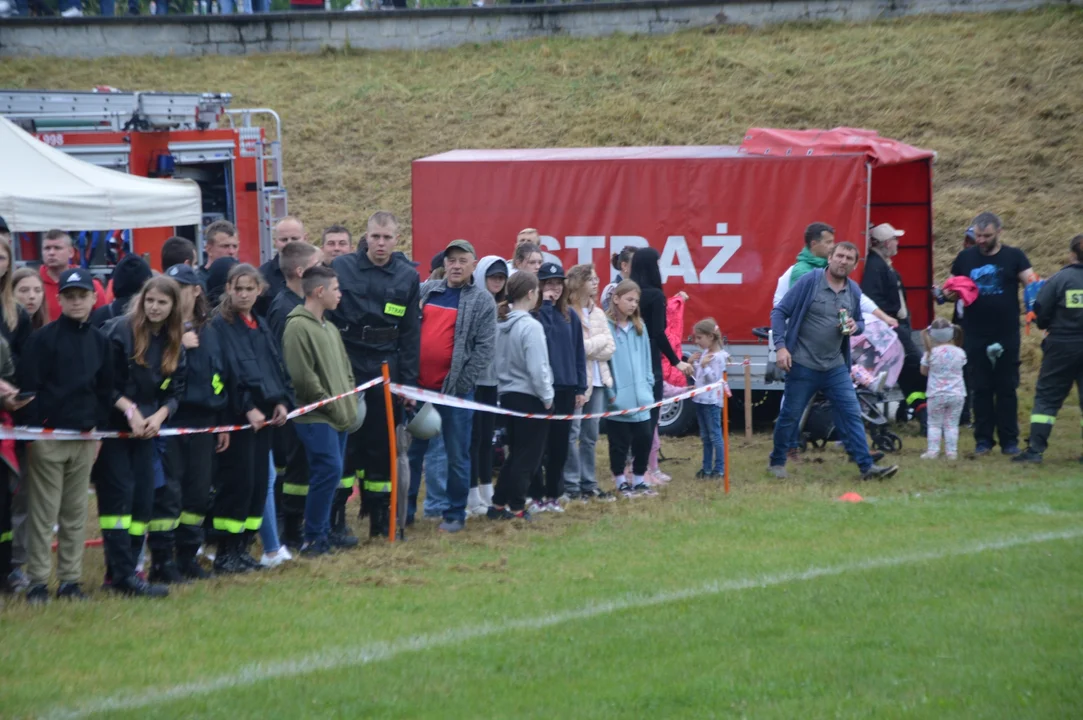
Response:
[293,422,347,542]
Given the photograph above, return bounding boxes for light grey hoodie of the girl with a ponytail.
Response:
[493,310,552,405]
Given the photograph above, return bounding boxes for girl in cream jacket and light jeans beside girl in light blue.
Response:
[564,264,616,501]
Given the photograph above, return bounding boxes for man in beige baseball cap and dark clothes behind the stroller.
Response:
[861,223,926,434]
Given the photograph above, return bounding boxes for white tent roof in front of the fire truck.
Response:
[0,117,203,233]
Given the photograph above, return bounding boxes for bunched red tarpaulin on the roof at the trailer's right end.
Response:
[741,128,936,168]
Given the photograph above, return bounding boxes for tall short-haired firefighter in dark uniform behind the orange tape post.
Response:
[331,212,421,537]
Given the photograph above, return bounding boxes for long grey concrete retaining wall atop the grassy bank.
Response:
[0,0,1065,57]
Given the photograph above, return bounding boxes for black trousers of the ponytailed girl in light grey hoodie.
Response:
[493,393,551,512]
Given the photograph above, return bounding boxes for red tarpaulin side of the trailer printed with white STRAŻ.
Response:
[413,140,935,342]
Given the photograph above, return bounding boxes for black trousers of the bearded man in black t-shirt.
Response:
[965,336,1019,448]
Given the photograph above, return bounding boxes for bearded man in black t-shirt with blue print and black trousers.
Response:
[948,212,1036,455]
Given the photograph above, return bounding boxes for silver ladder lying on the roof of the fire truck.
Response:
[0,89,233,132]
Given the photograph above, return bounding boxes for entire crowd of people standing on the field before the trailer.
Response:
[0,211,1083,603]
